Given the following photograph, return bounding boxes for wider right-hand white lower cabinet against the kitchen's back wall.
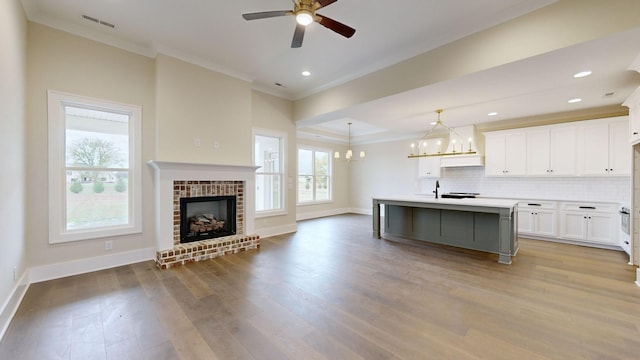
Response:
[560,203,619,245]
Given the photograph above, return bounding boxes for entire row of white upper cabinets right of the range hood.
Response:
[484,116,632,176]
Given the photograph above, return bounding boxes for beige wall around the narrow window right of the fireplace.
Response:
[251,91,297,235]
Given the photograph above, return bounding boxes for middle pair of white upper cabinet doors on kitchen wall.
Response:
[527,126,577,176]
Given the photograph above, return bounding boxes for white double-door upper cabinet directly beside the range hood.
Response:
[485,131,527,176]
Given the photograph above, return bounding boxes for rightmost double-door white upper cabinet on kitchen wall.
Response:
[580,116,631,176]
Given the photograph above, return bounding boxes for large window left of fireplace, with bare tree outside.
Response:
[47,91,142,243]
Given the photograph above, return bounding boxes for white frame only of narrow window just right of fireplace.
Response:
[251,128,288,218]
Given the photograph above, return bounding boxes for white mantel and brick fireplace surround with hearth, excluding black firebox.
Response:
[149,161,260,269]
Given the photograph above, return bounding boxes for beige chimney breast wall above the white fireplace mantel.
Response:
[155,55,251,165]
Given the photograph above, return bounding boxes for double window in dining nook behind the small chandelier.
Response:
[298,148,331,204]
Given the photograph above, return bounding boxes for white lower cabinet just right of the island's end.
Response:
[518,201,558,237]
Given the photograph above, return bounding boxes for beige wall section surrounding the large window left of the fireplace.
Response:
[26,23,155,267]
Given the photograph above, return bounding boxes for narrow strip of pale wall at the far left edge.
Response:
[0,0,27,310]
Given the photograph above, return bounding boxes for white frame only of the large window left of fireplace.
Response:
[47,90,142,244]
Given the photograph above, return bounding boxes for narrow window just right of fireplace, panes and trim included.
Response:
[253,130,286,216]
